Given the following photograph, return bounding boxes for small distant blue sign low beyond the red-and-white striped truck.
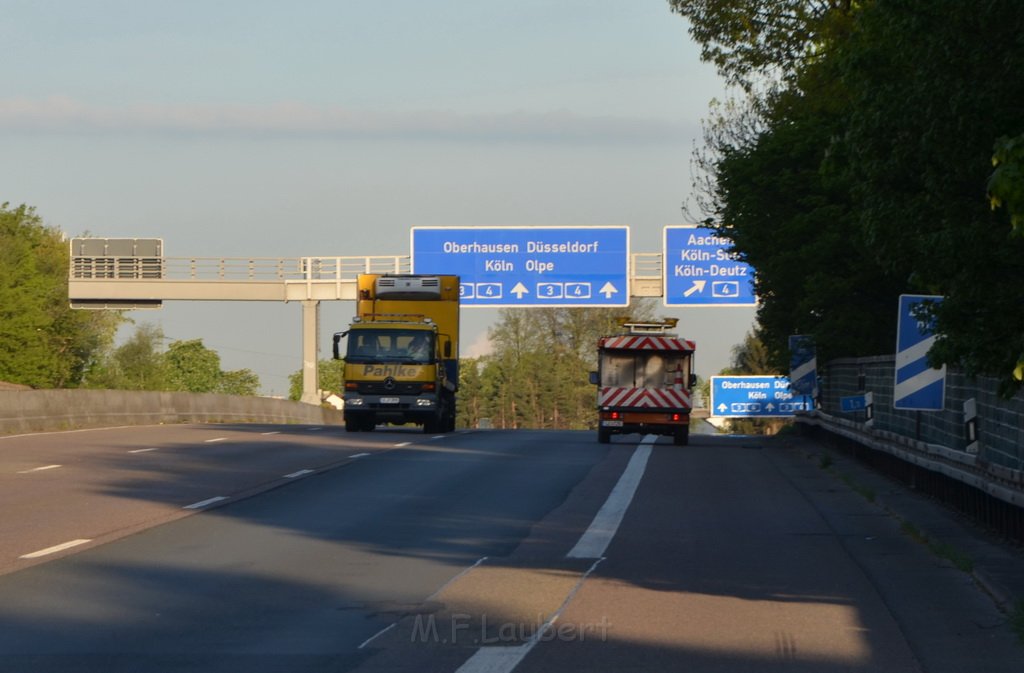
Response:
[710,376,813,418]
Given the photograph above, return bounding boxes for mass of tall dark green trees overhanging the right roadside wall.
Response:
[670,0,1024,391]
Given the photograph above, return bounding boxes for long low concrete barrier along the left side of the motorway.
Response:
[0,390,344,434]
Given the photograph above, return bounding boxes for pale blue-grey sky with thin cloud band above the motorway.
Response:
[0,0,754,394]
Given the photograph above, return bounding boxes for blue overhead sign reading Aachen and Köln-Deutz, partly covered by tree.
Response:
[663,226,757,306]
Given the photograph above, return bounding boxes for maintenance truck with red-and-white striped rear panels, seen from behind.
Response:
[590,318,696,446]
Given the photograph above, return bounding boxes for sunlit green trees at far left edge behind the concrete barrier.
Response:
[0,203,121,388]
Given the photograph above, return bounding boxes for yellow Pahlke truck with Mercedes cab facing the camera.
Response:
[334,274,459,433]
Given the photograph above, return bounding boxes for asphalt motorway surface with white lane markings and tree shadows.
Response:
[0,425,1024,673]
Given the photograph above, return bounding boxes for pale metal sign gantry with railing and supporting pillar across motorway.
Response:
[68,238,664,405]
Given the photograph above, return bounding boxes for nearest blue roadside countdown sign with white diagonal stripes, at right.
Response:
[893,294,946,411]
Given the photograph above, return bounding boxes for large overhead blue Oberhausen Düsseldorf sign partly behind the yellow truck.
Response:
[411,226,630,306]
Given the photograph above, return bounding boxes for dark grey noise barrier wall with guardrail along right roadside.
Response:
[797,355,1024,540]
